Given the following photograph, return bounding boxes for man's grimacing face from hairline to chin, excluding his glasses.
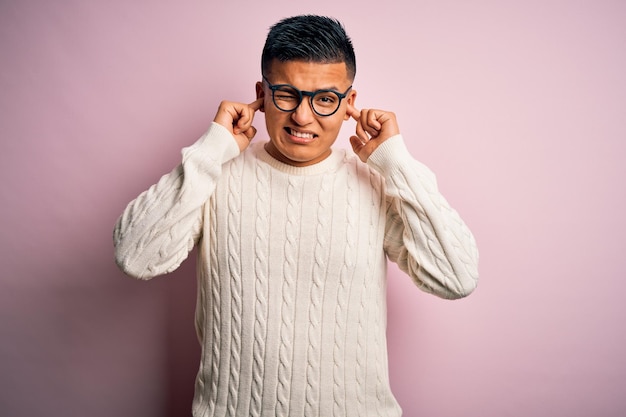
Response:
[256,60,356,166]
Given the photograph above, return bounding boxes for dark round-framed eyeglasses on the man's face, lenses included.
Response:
[263,75,352,117]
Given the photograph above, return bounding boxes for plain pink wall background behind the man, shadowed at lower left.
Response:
[0,0,626,417]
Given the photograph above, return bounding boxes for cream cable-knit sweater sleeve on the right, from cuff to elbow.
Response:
[367,135,478,299]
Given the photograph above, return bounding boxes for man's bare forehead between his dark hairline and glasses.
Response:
[266,60,350,91]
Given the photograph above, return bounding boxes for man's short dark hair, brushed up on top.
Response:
[261,15,356,81]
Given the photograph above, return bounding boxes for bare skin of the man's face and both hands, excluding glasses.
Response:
[214,61,400,167]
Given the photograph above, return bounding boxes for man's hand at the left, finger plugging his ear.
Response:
[213,98,263,152]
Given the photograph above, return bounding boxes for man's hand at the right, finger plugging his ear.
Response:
[348,104,400,162]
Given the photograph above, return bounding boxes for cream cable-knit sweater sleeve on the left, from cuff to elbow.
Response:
[113,123,239,279]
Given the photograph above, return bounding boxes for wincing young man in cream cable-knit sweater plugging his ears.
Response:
[114,16,478,416]
